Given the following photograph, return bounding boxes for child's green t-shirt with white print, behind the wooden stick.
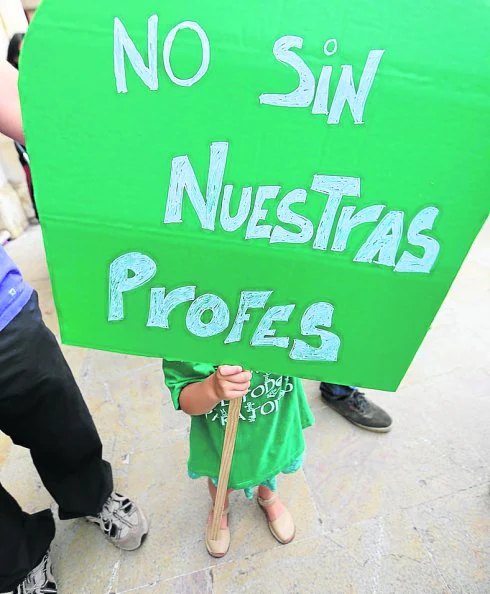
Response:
[163,361,313,489]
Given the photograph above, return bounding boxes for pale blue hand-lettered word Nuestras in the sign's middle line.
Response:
[163,142,440,273]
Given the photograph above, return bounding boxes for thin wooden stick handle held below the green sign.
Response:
[211,398,242,540]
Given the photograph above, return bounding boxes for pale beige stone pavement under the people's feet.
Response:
[0,223,490,594]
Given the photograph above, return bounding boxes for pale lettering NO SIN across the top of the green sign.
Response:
[114,14,384,124]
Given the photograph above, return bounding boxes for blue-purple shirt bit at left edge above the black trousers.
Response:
[0,246,32,332]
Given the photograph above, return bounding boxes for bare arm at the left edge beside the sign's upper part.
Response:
[0,61,25,144]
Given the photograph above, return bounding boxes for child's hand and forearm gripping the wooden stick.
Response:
[179,365,252,415]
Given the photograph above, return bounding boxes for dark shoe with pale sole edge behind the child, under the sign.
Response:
[320,384,393,433]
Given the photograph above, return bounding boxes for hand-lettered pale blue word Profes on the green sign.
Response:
[108,252,340,361]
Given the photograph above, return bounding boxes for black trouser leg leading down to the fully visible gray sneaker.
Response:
[0,294,113,591]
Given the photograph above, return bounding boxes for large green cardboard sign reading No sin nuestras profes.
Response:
[21,0,490,390]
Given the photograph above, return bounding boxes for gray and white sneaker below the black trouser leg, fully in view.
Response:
[87,493,148,551]
